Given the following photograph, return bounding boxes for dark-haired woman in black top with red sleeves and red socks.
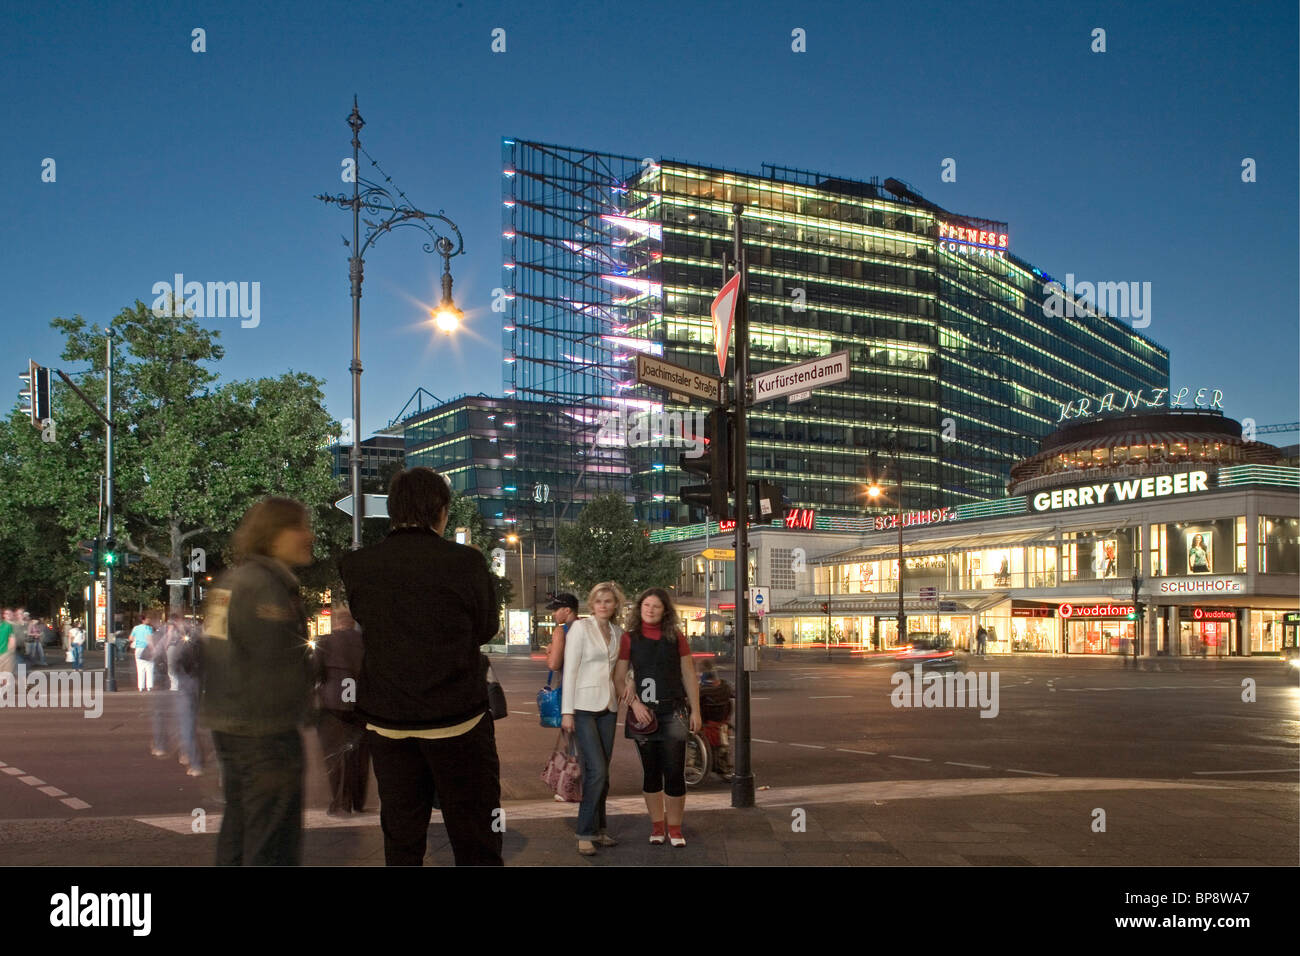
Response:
[614,588,703,847]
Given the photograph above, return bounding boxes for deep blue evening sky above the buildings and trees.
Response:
[0,0,1300,444]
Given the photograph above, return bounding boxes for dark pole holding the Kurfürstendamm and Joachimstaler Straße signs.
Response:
[723,203,754,808]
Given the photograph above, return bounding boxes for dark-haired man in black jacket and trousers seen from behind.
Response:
[341,468,503,866]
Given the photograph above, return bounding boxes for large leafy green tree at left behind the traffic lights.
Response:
[0,300,335,610]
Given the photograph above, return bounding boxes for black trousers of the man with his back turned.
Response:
[367,714,506,866]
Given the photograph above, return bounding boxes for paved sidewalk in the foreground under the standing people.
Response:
[0,778,1300,866]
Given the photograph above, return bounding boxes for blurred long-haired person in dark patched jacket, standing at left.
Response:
[199,498,316,866]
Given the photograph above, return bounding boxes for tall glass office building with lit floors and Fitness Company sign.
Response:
[503,139,1169,524]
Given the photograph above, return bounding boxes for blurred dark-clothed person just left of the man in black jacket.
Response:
[316,601,371,817]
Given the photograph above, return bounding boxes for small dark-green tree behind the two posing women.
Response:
[559,492,680,597]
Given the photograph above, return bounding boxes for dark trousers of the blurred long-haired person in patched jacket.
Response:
[212,730,303,866]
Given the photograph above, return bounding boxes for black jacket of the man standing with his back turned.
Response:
[341,528,499,730]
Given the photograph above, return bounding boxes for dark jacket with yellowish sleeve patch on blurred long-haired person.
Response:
[199,555,316,736]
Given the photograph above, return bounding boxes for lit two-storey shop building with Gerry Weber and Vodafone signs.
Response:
[653,416,1300,658]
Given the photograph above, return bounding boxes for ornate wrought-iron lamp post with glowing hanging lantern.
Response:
[316,96,465,551]
